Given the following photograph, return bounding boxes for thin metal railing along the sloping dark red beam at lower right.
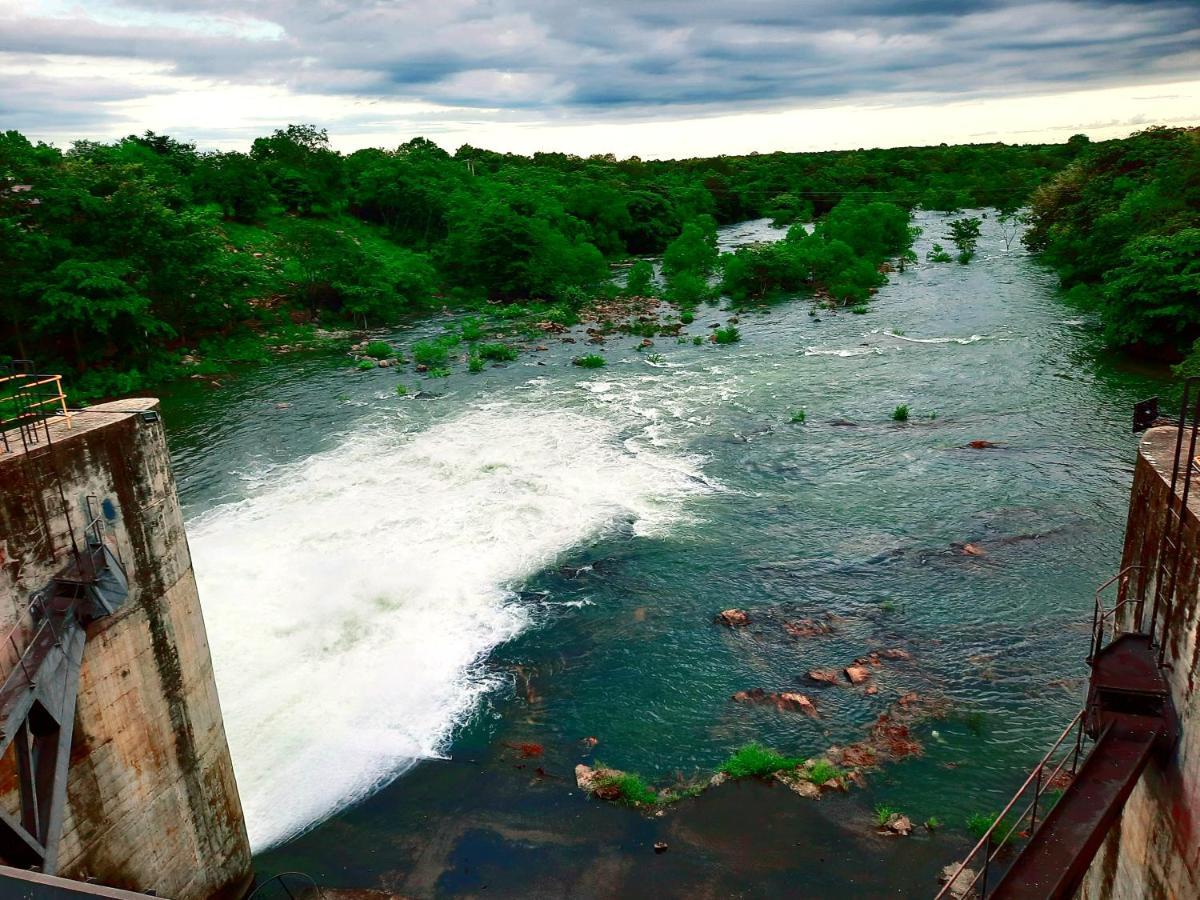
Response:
[935,709,1087,900]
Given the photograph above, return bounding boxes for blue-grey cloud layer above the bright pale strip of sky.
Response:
[0,0,1200,133]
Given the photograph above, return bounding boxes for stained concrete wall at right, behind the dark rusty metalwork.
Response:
[1080,427,1200,900]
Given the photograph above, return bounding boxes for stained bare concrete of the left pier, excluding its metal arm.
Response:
[0,398,251,900]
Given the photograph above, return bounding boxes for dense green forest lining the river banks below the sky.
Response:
[0,126,1200,397]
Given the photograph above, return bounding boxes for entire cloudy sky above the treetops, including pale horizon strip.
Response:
[0,0,1200,158]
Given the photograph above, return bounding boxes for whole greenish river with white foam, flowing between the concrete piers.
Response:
[164,214,1163,895]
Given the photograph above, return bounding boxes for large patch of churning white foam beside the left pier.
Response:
[190,404,708,850]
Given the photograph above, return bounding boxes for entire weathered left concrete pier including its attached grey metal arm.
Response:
[0,398,251,900]
